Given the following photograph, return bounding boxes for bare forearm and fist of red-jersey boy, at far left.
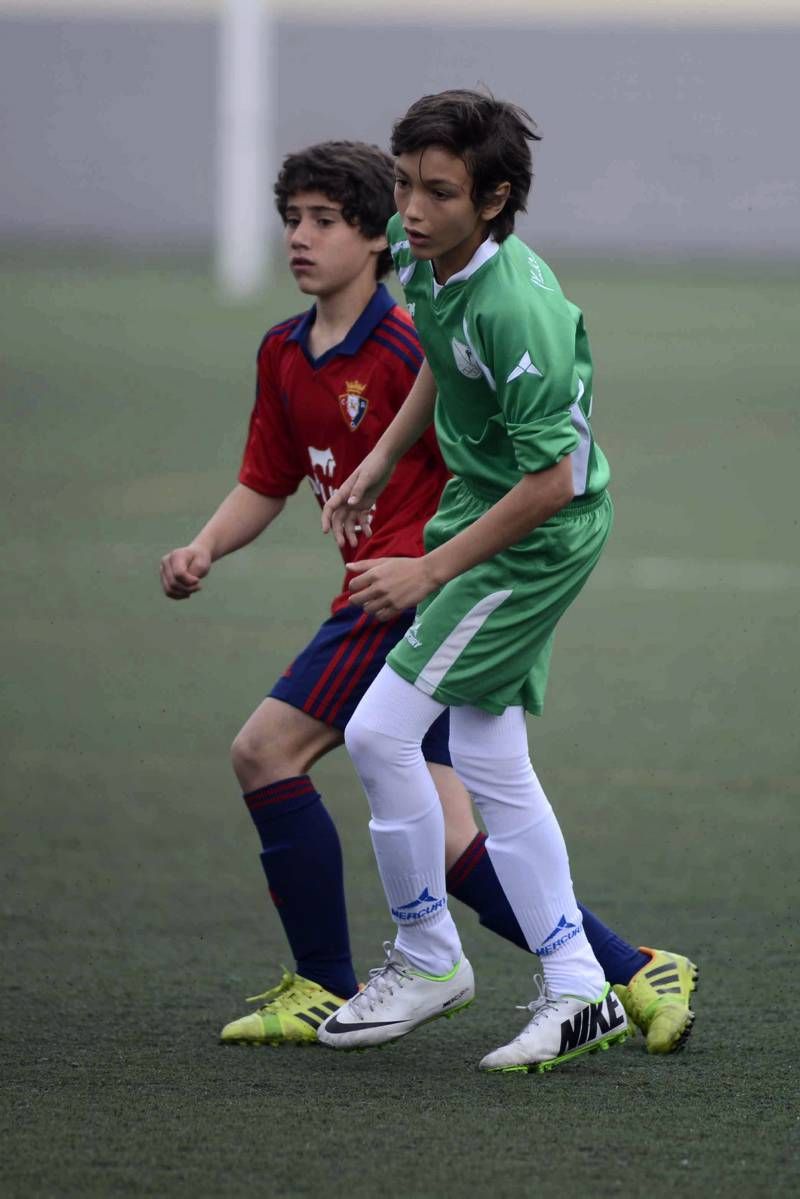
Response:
[161,483,285,600]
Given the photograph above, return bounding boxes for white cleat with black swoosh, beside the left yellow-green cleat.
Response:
[317,941,475,1049]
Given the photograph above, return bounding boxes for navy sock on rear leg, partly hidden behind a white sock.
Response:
[447,832,650,983]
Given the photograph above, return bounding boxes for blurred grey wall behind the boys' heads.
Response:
[0,0,800,267]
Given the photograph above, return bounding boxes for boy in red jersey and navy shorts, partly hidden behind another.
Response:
[161,141,690,1044]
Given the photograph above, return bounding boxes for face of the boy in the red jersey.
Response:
[284,192,386,297]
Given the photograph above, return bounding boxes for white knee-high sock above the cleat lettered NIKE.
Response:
[450,707,604,999]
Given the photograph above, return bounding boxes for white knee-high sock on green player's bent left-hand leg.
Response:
[344,667,461,975]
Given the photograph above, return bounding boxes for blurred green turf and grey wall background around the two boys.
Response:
[0,0,800,1199]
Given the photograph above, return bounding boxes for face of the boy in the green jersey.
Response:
[395,146,509,283]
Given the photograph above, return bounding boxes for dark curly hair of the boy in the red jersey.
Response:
[275,141,395,279]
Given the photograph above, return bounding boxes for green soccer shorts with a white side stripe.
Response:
[386,478,614,716]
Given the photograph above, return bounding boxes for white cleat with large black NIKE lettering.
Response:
[480,975,627,1074]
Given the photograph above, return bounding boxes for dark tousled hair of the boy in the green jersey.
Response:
[391,90,541,241]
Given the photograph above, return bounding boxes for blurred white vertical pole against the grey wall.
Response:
[216,0,276,300]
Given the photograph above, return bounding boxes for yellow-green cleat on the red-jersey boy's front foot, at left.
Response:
[219,970,347,1046]
